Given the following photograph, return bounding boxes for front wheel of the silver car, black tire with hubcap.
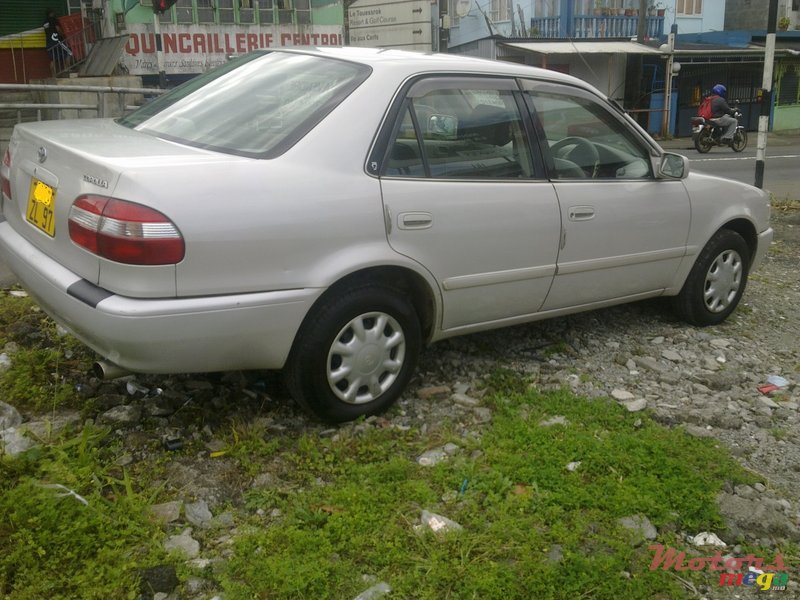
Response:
[673,229,750,327]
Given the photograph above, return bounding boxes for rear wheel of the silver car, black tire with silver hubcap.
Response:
[286,284,421,423]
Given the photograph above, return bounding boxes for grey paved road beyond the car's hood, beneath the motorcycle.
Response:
[661,131,800,200]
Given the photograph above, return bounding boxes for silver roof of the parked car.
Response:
[266,46,605,97]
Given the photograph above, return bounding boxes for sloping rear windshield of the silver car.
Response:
[118,52,370,158]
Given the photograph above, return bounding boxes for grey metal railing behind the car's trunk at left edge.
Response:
[0,83,167,123]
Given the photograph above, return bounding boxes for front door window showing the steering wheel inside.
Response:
[528,90,651,179]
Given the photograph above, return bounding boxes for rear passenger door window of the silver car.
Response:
[383,80,533,179]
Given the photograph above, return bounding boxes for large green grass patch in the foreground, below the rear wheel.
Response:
[222,386,747,599]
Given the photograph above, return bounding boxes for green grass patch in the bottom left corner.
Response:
[0,427,170,600]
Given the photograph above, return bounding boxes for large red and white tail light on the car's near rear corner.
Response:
[69,195,185,265]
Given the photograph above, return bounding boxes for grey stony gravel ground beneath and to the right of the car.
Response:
[1,210,800,598]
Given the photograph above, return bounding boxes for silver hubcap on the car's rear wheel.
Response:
[327,312,406,404]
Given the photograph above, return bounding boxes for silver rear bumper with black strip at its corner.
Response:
[0,222,323,373]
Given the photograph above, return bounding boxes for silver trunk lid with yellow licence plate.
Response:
[4,119,230,297]
